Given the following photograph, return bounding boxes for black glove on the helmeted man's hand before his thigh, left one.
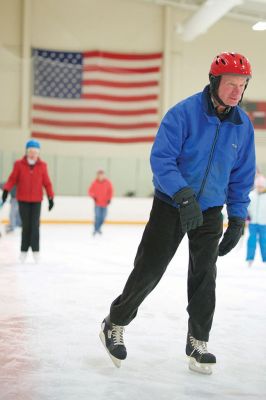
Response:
[173,186,203,233]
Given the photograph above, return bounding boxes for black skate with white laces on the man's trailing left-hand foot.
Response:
[100,316,127,368]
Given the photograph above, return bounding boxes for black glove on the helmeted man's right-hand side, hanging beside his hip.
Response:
[219,217,245,256]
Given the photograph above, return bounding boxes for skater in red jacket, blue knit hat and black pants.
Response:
[2,140,54,262]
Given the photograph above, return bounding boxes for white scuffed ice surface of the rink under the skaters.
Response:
[0,225,266,400]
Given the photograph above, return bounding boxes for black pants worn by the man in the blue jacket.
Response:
[110,198,223,341]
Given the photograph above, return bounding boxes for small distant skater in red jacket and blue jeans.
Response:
[88,170,113,235]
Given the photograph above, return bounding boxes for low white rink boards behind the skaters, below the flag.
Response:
[0,196,152,224]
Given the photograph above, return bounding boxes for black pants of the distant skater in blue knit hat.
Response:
[19,201,41,251]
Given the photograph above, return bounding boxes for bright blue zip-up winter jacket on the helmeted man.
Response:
[150,86,255,218]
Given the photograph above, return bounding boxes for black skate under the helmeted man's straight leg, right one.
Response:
[186,333,216,375]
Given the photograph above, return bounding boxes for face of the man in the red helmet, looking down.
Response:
[218,75,247,107]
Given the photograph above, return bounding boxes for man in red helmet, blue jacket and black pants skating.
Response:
[100,53,255,374]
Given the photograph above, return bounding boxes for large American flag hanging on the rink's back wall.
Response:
[31,49,162,143]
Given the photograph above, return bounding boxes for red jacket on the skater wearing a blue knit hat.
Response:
[4,156,54,203]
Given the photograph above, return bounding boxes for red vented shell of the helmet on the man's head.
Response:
[210,52,252,78]
